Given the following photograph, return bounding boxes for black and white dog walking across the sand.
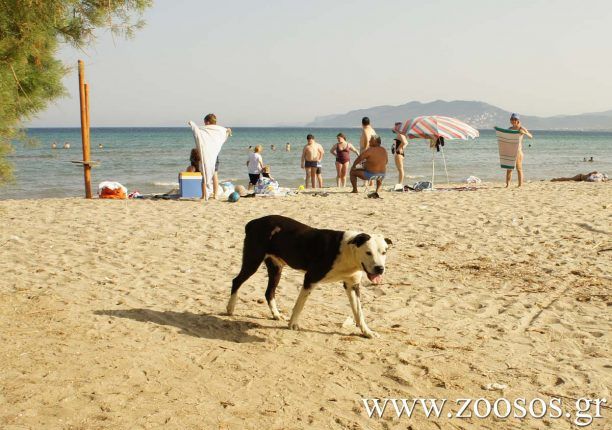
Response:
[227,215,392,337]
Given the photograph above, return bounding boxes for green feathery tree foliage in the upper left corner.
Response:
[0,0,152,183]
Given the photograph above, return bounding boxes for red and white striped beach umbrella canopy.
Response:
[402,115,480,140]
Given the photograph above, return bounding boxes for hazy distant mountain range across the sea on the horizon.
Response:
[307,100,612,130]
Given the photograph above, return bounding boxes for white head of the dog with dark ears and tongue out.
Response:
[348,233,393,284]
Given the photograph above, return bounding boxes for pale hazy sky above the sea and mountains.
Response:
[29,0,612,126]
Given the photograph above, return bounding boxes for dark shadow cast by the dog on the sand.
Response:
[94,309,268,343]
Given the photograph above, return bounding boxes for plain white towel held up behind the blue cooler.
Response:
[189,121,227,200]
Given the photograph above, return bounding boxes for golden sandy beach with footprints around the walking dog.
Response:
[0,182,612,430]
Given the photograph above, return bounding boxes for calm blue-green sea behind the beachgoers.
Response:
[0,127,612,199]
